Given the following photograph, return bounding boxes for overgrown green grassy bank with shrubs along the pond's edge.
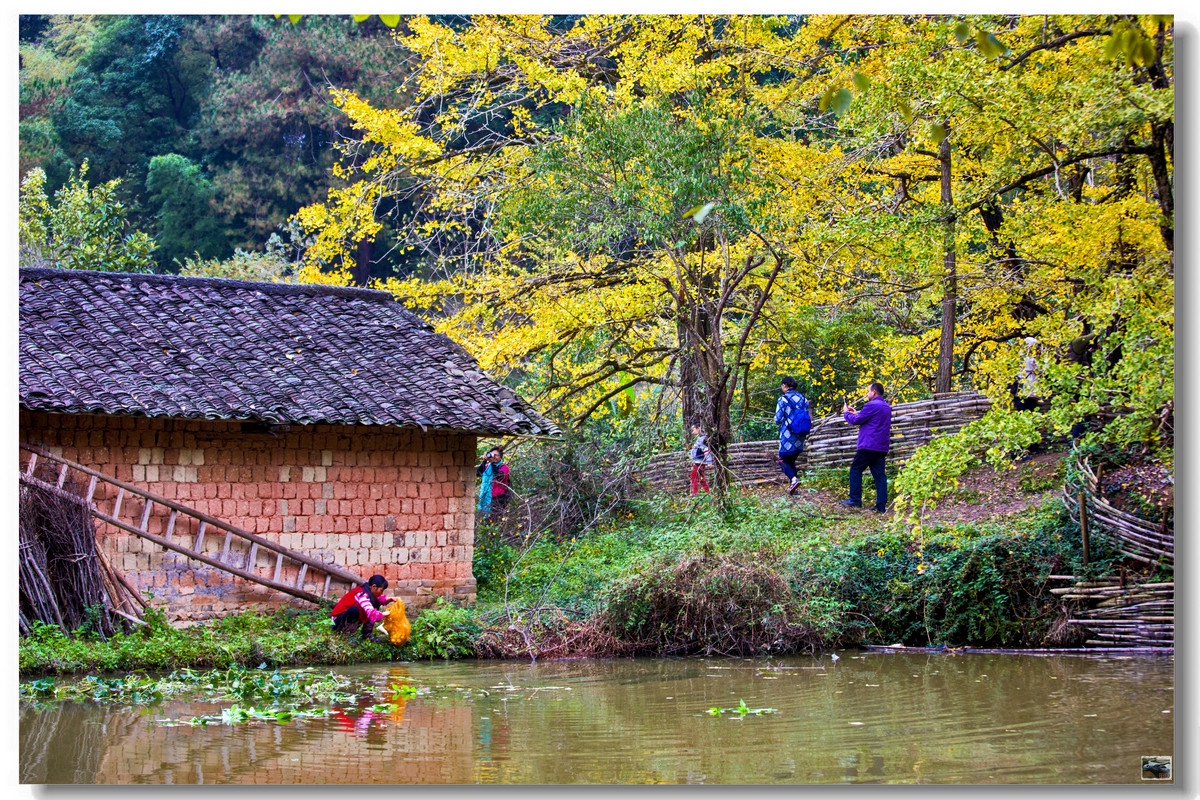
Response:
[19,476,1106,676]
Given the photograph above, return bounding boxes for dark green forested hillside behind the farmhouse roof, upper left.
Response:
[20,14,409,278]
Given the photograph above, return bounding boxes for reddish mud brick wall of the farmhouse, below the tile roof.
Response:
[20,411,475,621]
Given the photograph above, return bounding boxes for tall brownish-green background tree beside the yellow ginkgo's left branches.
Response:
[187,17,408,283]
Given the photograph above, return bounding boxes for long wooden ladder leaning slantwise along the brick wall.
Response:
[20,444,362,604]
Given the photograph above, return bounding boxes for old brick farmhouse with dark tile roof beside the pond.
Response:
[19,269,558,620]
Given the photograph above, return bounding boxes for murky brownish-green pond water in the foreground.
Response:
[19,651,1175,784]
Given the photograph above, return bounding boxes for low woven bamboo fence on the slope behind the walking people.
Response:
[638,392,991,494]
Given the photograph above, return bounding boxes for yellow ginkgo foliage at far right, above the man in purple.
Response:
[801,16,1174,520]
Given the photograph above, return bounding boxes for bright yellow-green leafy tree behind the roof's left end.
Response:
[18,161,155,272]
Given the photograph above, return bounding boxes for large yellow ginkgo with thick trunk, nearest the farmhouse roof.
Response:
[300,17,849,496]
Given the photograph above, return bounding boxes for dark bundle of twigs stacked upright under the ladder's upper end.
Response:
[18,462,144,639]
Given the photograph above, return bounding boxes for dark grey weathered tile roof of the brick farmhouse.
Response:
[18,269,559,435]
